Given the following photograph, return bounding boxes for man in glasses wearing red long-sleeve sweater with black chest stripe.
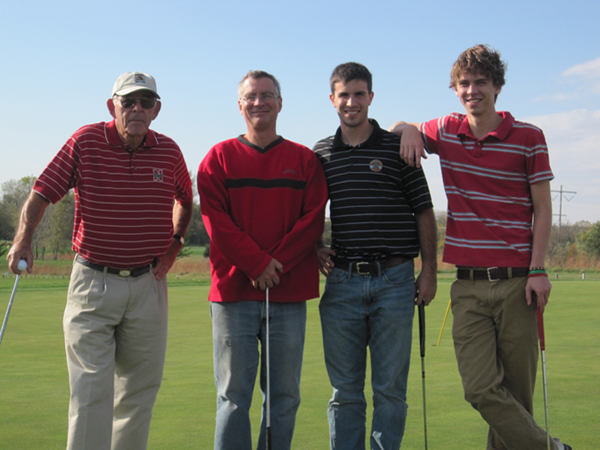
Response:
[198,71,327,450]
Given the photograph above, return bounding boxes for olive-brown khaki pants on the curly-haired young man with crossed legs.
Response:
[451,277,556,450]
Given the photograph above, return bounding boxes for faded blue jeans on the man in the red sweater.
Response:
[210,301,306,450]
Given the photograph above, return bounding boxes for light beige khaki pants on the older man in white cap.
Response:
[63,263,167,450]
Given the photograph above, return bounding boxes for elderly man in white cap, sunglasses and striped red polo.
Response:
[7,72,192,450]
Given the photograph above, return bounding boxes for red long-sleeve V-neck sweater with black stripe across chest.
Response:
[198,134,327,302]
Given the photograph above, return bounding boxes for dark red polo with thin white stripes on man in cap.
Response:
[33,120,193,269]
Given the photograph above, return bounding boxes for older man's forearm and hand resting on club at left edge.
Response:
[6,191,50,275]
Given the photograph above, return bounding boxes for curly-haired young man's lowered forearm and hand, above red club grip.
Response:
[525,180,552,312]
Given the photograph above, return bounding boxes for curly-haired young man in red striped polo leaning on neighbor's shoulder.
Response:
[391,45,571,450]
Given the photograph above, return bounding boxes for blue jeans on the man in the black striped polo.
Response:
[319,261,415,450]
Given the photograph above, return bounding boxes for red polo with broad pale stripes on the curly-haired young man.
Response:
[419,112,554,267]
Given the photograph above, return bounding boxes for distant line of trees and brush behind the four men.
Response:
[0,173,600,270]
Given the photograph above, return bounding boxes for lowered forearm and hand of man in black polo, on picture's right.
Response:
[415,208,437,305]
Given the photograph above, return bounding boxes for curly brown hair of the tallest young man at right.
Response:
[450,44,506,89]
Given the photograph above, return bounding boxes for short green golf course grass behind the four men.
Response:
[0,278,600,450]
